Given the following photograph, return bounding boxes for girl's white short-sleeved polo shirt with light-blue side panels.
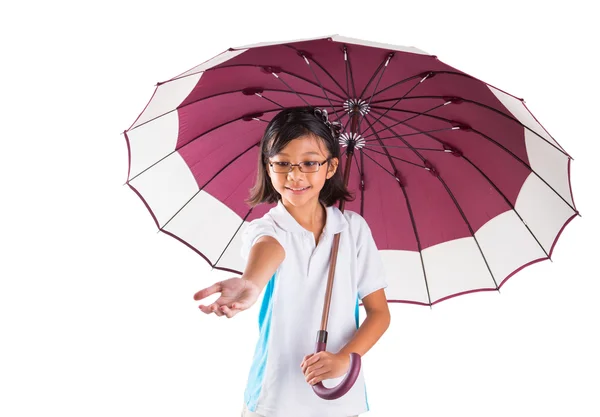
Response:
[241,201,387,417]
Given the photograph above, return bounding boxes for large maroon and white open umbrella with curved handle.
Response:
[124,35,579,399]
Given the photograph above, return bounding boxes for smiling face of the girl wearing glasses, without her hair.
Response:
[266,135,338,206]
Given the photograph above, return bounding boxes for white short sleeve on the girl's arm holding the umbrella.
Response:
[357,215,387,300]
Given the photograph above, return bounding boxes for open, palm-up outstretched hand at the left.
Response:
[194,278,260,318]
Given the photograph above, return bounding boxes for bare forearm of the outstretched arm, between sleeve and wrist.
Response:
[242,236,285,293]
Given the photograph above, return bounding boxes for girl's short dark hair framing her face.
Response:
[245,106,355,208]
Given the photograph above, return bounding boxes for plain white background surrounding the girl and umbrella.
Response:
[0,0,600,417]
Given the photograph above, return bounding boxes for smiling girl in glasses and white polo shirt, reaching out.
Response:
[194,107,390,417]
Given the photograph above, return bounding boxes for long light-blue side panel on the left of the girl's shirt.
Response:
[244,274,277,412]
